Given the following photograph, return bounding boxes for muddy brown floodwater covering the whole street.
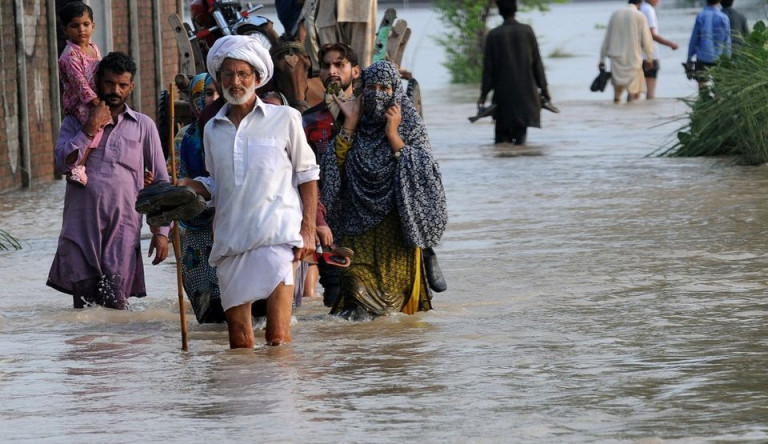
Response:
[0,3,768,444]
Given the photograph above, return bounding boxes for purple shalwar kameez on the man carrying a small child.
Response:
[47,106,169,309]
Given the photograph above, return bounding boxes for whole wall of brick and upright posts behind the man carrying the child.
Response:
[0,0,180,192]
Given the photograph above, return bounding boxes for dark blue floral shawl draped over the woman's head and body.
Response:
[320,62,448,248]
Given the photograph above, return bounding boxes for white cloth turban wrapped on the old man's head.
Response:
[206,35,274,88]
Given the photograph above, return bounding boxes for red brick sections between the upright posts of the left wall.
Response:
[0,0,178,192]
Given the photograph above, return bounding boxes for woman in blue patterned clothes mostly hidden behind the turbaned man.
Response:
[173,73,225,324]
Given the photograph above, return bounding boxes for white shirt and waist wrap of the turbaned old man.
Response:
[203,100,319,310]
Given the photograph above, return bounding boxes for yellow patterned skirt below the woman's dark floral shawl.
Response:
[331,211,432,319]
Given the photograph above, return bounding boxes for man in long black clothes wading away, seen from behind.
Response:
[477,0,550,145]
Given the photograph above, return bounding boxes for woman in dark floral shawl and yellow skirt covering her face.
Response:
[320,62,448,319]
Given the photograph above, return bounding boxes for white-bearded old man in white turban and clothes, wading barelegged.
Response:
[180,36,319,348]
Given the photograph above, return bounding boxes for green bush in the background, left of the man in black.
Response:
[434,0,566,83]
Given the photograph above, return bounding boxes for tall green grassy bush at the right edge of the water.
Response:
[661,22,768,164]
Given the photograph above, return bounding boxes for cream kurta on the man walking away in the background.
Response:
[600,4,653,94]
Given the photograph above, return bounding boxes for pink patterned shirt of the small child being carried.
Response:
[59,40,101,124]
